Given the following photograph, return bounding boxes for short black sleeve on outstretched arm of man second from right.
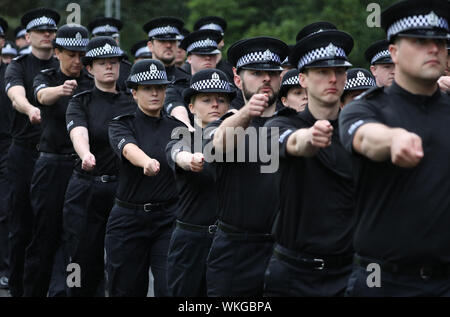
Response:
[264,117,299,158]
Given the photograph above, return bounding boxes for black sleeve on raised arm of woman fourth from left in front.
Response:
[108,117,139,159]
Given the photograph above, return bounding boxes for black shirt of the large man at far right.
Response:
[339,82,450,264]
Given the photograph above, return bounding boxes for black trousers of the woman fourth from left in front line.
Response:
[105,203,176,297]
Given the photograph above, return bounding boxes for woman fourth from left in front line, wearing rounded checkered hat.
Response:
[105,59,183,297]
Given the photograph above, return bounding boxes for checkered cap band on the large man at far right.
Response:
[387,12,448,40]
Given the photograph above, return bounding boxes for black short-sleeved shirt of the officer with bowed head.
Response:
[33,68,94,154]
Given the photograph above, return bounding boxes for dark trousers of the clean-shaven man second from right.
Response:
[264,243,352,297]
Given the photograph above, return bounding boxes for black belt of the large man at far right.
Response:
[354,255,450,280]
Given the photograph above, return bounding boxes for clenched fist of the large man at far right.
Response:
[391,129,424,168]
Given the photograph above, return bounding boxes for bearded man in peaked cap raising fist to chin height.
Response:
[204,37,288,296]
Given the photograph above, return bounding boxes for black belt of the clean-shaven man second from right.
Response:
[273,244,353,271]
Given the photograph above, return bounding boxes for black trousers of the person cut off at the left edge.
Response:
[0,140,11,277]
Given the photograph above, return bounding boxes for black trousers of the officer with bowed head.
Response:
[24,156,74,297]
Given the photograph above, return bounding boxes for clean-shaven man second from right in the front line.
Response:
[265,25,354,296]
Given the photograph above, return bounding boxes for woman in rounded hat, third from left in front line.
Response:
[63,36,136,296]
